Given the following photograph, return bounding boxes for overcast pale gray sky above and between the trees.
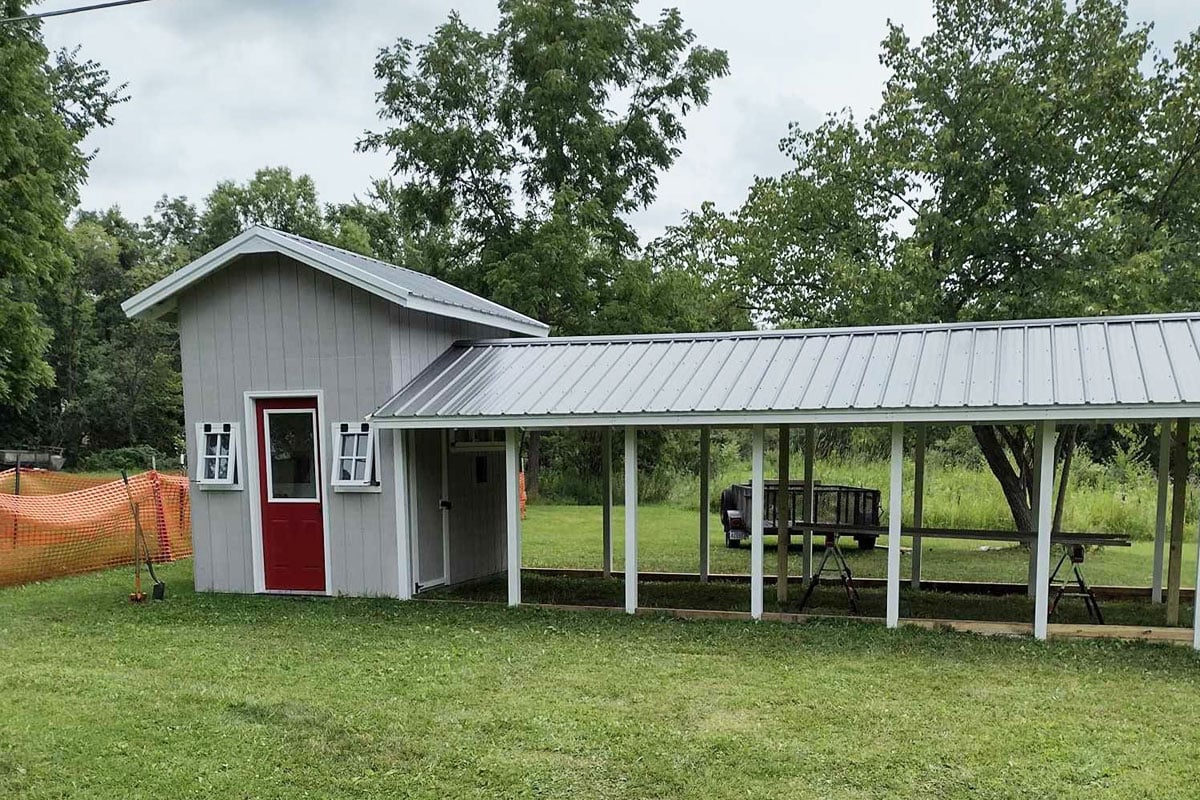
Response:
[38,0,1200,239]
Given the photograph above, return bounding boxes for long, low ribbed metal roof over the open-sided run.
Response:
[372,313,1200,427]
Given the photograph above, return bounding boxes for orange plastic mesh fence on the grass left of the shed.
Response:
[0,468,192,587]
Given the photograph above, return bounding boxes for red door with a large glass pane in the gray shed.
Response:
[257,397,325,591]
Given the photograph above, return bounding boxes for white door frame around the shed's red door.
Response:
[242,389,334,595]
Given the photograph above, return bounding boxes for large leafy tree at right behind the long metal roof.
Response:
[691,0,1200,530]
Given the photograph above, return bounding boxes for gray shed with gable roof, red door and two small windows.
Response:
[124,227,548,597]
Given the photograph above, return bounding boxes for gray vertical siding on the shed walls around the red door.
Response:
[179,253,504,595]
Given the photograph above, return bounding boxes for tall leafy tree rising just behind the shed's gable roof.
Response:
[359,0,728,333]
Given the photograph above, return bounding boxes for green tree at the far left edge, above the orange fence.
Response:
[0,7,124,408]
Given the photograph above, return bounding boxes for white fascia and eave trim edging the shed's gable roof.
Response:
[121,227,550,337]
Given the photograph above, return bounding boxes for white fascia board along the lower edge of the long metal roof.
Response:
[367,404,1200,431]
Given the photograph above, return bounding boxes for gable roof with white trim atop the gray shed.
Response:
[121,225,550,336]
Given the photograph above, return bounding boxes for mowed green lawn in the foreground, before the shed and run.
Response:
[7,561,1200,800]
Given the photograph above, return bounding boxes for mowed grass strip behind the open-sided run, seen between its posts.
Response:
[522,504,1196,587]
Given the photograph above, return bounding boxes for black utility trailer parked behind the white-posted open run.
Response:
[721,481,881,551]
